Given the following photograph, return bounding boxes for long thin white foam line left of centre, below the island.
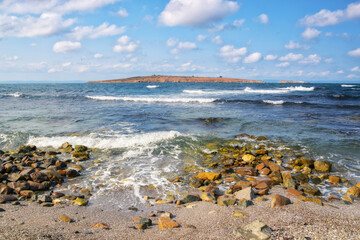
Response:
[86,96,216,103]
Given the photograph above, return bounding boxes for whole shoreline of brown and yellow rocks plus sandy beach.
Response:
[0,134,360,239]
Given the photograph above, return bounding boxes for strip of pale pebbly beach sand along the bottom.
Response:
[0,187,360,239]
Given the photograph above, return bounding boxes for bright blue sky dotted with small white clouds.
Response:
[0,0,360,83]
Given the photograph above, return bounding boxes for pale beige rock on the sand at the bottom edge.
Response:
[233,220,272,240]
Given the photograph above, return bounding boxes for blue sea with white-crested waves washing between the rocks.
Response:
[0,83,360,204]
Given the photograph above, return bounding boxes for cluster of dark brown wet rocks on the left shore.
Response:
[0,143,90,207]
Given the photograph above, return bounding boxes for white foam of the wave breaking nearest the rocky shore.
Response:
[27,131,181,149]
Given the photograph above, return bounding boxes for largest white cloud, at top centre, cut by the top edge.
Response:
[159,0,239,27]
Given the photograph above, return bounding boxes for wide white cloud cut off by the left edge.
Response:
[0,13,75,38]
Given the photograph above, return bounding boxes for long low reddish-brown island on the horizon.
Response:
[88,75,265,83]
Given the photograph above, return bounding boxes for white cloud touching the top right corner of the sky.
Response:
[299,3,360,27]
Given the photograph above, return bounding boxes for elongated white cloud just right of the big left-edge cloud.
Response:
[67,22,126,40]
